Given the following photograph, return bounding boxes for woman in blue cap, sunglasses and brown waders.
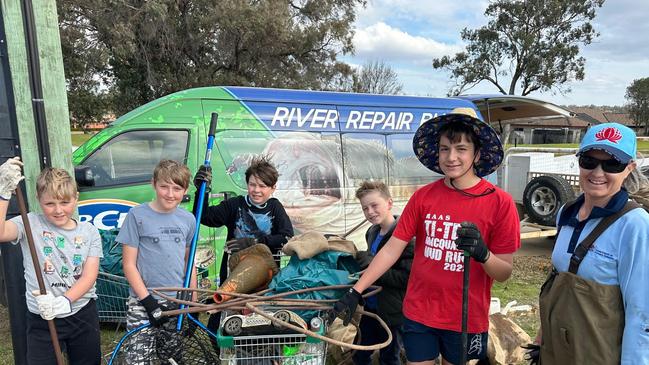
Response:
[530,123,649,364]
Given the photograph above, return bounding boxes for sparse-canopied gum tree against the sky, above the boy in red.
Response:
[433,0,604,95]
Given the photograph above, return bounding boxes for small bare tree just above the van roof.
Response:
[351,61,403,95]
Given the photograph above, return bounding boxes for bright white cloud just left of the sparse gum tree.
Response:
[354,22,461,67]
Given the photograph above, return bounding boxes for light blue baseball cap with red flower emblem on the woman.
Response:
[577,123,637,163]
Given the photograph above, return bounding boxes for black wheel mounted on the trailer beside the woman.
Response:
[523,175,575,226]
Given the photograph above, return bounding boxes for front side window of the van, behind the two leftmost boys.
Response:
[81,129,189,187]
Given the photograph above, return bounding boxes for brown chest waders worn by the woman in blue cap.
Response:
[539,272,624,365]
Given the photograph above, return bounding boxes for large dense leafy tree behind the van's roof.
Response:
[59,0,365,112]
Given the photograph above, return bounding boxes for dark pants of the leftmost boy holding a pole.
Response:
[27,300,101,365]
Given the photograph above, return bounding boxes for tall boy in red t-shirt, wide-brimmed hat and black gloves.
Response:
[334,108,520,365]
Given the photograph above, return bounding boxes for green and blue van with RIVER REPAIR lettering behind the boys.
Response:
[73,87,475,296]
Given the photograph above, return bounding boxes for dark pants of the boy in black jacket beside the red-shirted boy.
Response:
[353,309,402,365]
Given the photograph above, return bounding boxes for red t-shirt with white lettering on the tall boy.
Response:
[393,179,520,333]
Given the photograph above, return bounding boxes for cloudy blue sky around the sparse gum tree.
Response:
[343,0,649,105]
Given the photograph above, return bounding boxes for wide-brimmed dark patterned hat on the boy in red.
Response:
[412,108,504,177]
